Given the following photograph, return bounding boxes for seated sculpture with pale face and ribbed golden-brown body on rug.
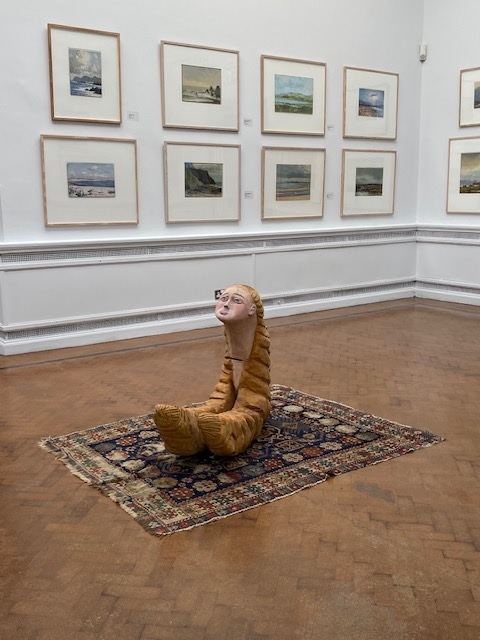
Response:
[154,284,271,456]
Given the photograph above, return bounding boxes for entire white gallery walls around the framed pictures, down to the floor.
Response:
[0,0,480,354]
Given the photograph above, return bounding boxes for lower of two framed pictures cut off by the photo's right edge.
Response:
[447,137,480,213]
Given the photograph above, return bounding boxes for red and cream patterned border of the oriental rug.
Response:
[38,384,445,536]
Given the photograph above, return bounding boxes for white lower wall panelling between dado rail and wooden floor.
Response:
[0,225,480,355]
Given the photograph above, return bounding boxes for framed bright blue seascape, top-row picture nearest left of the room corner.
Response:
[343,67,398,140]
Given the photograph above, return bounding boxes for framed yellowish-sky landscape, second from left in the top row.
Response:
[160,41,239,131]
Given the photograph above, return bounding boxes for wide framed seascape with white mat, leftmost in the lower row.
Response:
[40,135,138,227]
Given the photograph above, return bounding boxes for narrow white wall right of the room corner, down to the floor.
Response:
[417,0,480,305]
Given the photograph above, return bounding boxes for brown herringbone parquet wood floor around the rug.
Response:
[0,300,480,640]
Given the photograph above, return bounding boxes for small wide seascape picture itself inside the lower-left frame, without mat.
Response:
[67,162,115,198]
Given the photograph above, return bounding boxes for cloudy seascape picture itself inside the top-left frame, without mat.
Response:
[68,48,102,98]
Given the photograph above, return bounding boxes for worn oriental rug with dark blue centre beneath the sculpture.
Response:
[40,385,443,536]
